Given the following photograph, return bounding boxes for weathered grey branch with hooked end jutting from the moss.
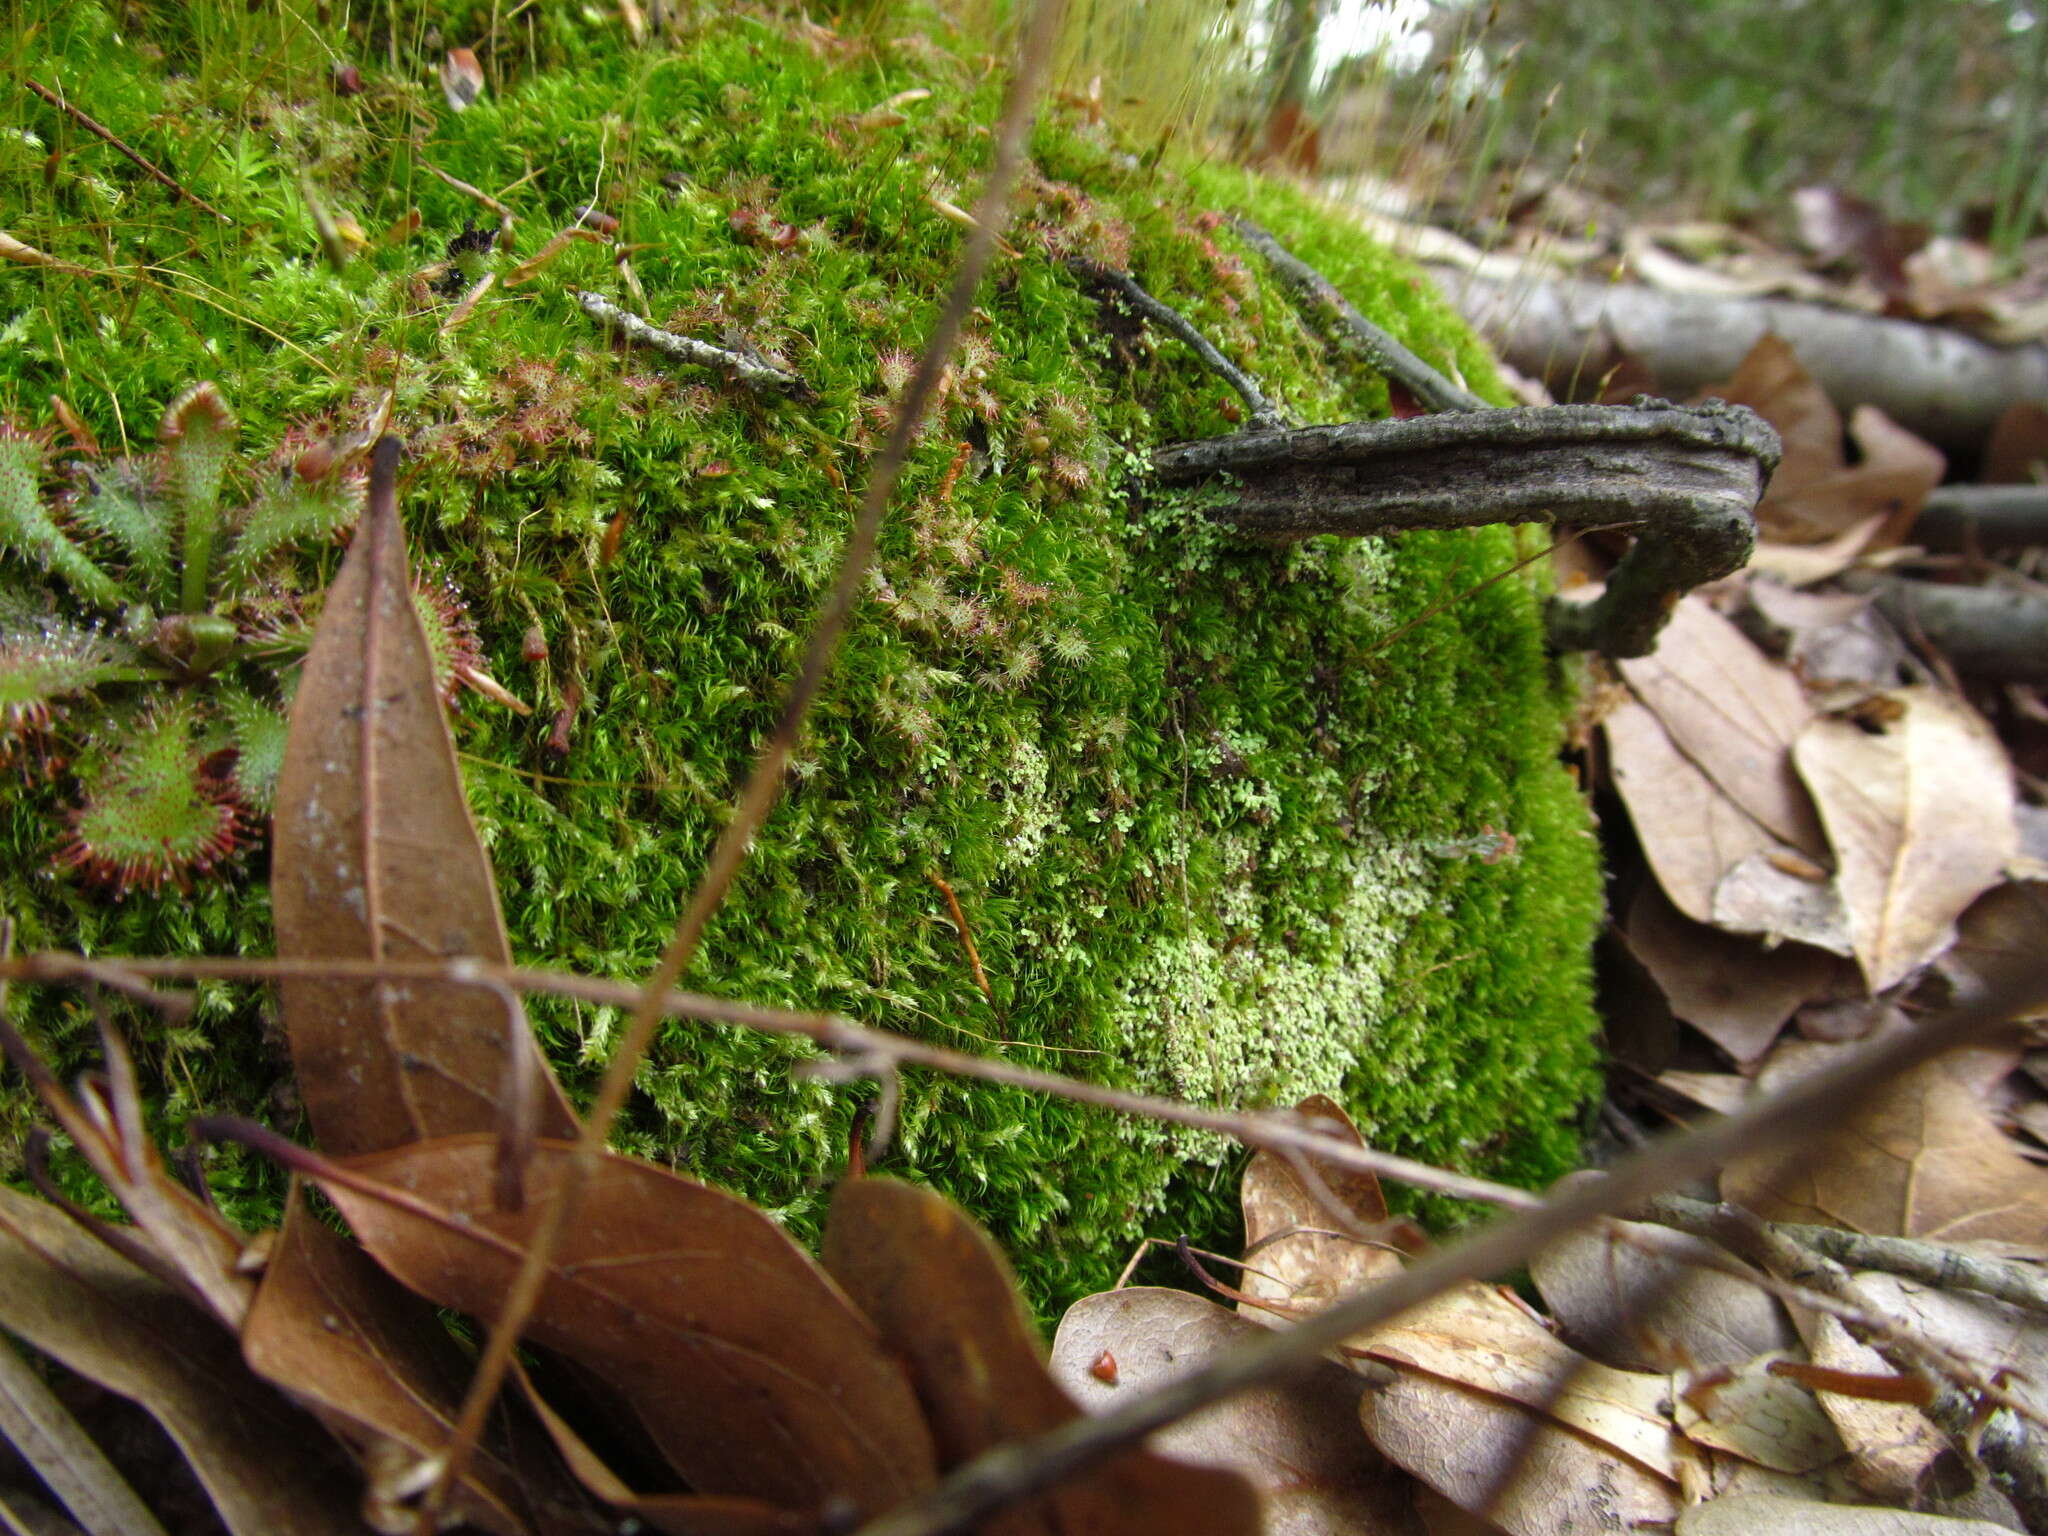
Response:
[1153,397,1778,655]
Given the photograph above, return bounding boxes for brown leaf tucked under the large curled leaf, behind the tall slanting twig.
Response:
[242,1184,604,1532]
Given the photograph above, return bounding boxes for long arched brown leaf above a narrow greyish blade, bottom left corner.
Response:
[0,1186,362,1536]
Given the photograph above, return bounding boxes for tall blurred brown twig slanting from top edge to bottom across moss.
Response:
[432,0,1061,1532]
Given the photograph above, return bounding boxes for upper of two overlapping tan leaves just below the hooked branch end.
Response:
[1616,596,1827,856]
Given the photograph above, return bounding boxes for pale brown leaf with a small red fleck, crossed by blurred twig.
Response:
[1053,1286,1419,1536]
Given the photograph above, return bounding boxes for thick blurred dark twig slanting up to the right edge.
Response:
[843,965,2048,1536]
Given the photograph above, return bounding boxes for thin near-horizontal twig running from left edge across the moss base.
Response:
[0,952,1540,1210]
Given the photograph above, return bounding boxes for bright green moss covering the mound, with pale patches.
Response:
[0,4,1599,1327]
